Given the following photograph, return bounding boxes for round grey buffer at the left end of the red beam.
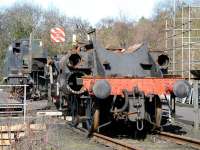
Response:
[92,80,111,99]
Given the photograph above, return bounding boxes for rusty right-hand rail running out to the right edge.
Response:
[158,132,200,149]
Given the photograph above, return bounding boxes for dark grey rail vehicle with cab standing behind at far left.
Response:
[3,38,48,99]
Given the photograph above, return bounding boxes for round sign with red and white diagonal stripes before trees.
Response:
[50,27,65,43]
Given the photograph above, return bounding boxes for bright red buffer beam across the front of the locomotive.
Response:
[83,77,179,95]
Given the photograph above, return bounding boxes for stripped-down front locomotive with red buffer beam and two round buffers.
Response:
[52,31,190,131]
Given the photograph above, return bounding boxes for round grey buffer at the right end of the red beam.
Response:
[173,80,191,98]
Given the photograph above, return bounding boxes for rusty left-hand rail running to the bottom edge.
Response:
[93,133,141,150]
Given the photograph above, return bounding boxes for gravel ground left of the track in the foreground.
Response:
[8,118,109,150]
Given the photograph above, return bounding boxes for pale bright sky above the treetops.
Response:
[0,0,166,25]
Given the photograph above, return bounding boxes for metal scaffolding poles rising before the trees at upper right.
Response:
[165,0,200,80]
